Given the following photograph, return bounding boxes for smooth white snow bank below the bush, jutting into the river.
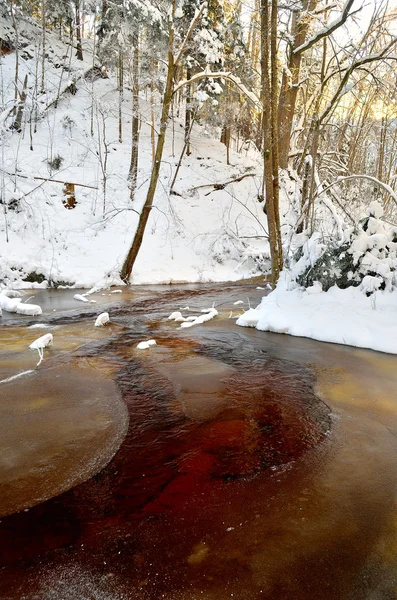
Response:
[237,282,397,354]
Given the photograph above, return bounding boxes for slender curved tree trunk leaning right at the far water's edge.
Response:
[120,18,176,282]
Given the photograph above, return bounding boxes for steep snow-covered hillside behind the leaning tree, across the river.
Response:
[0,11,284,287]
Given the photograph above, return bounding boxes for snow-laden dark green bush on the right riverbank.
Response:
[292,201,397,296]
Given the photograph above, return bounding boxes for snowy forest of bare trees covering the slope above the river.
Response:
[0,0,397,352]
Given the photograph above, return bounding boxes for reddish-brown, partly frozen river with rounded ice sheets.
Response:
[0,282,397,600]
